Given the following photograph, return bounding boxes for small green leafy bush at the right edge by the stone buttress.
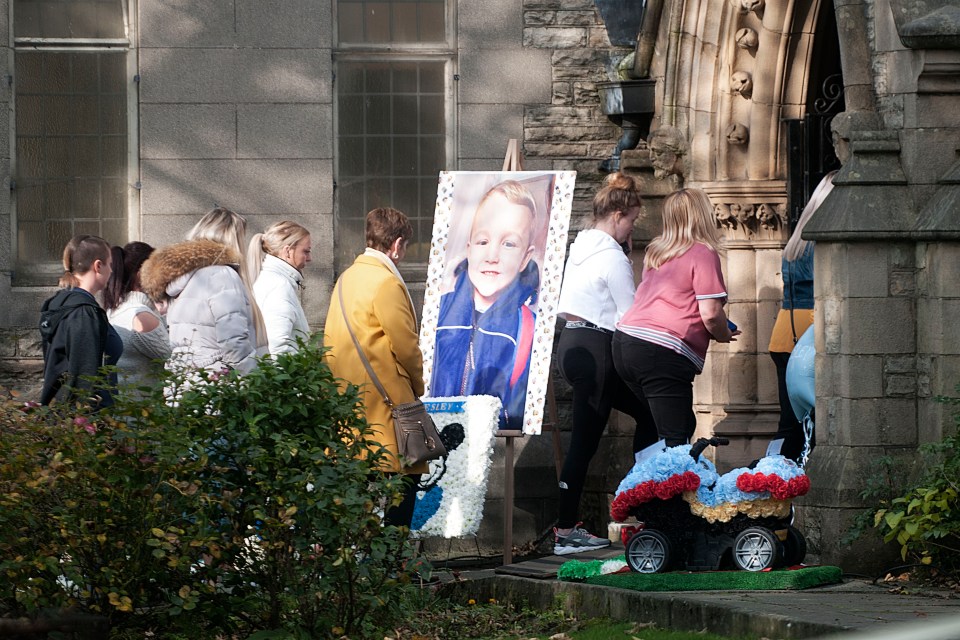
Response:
[874,398,960,573]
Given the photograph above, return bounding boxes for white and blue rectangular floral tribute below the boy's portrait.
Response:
[410,396,500,538]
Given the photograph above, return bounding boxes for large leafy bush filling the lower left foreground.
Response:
[0,343,418,638]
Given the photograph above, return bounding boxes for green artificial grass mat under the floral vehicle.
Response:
[561,561,843,591]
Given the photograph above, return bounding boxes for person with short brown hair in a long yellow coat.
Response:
[324,208,427,527]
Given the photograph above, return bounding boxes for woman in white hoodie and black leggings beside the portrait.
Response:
[554,173,657,555]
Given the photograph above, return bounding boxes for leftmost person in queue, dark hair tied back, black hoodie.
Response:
[40,235,123,408]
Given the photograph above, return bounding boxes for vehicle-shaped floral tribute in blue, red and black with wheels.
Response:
[610,438,810,573]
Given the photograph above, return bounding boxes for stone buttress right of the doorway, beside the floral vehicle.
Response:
[799,126,918,571]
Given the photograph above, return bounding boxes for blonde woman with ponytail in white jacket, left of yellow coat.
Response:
[247,220,312,356]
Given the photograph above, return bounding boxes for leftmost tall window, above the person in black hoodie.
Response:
[12,0,131,281]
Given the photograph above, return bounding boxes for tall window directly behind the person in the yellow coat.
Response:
[336,0,453,270]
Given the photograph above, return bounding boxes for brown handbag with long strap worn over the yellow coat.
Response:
[337,278,447,467]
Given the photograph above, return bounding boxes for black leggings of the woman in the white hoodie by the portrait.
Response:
[557,327,657,529]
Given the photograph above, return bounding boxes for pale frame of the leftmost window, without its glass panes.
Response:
[7,0,142,287]
